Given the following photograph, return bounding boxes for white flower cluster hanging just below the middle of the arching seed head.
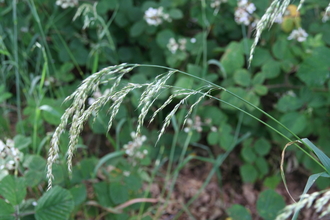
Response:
[123,132,148,163]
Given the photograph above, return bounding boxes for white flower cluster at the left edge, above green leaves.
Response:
[0,139,22,171]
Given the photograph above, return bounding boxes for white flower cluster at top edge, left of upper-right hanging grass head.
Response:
[235,0,256,26]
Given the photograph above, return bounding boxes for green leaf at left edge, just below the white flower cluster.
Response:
[0,175,26,205]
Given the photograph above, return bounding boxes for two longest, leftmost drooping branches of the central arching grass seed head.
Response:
[47,64,136,190]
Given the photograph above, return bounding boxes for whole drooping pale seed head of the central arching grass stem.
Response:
[47,64,215,189]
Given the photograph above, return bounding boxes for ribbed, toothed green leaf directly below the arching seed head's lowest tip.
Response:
[35,186,74,220]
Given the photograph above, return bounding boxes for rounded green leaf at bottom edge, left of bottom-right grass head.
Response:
[257,189,285,220]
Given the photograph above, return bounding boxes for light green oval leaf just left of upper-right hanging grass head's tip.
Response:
[220,42,244,75]
